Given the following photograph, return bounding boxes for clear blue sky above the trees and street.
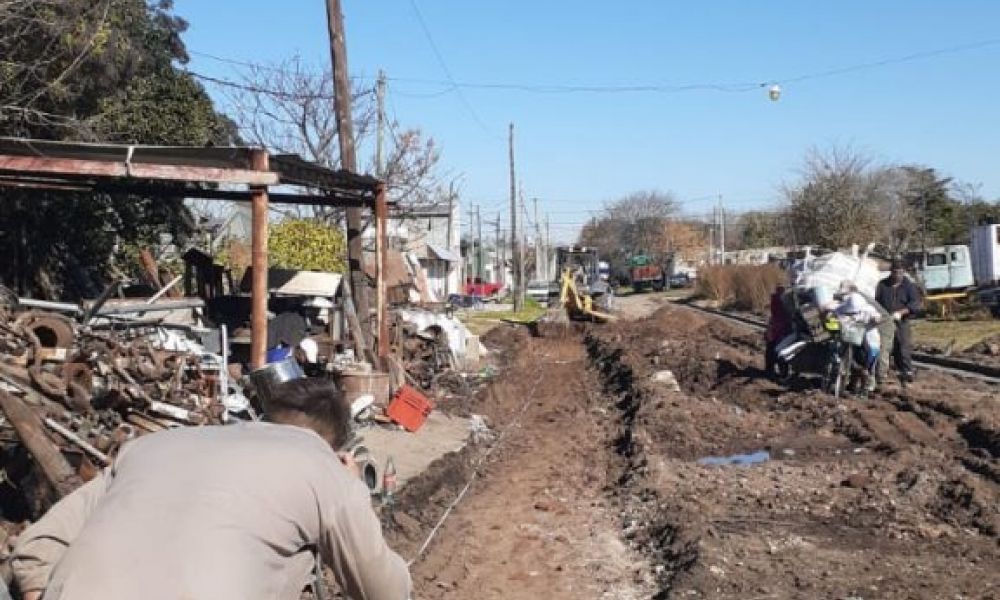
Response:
[175,0,1000,237]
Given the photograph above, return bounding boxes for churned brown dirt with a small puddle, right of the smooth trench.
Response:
[588,307,1000,598]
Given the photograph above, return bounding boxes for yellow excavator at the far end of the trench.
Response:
[556,246,615,323]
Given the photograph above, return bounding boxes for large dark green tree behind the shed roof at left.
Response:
[0,0,235,298]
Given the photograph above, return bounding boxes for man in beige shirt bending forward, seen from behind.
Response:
[12,379,410,600]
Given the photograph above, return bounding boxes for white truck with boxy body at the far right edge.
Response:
[911,224,1000,317]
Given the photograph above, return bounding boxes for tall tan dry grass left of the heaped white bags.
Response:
[697,265,788,312]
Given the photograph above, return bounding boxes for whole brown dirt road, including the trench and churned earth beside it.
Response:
[390,296,1000,599]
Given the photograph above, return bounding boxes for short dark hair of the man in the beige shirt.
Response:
[264,377,351,449]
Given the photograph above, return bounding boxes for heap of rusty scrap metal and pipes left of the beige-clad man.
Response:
[0,292,227,519]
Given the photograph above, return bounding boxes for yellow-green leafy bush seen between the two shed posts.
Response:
[267,219,347,273]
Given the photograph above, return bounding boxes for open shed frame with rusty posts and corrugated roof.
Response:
[0,137,389,367]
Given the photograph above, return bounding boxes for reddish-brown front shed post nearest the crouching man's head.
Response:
[250,150,269,369]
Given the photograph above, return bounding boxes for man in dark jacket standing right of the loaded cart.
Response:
[875,260,920,381]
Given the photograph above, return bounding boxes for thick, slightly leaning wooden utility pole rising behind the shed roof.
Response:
[326,0,371,349]
